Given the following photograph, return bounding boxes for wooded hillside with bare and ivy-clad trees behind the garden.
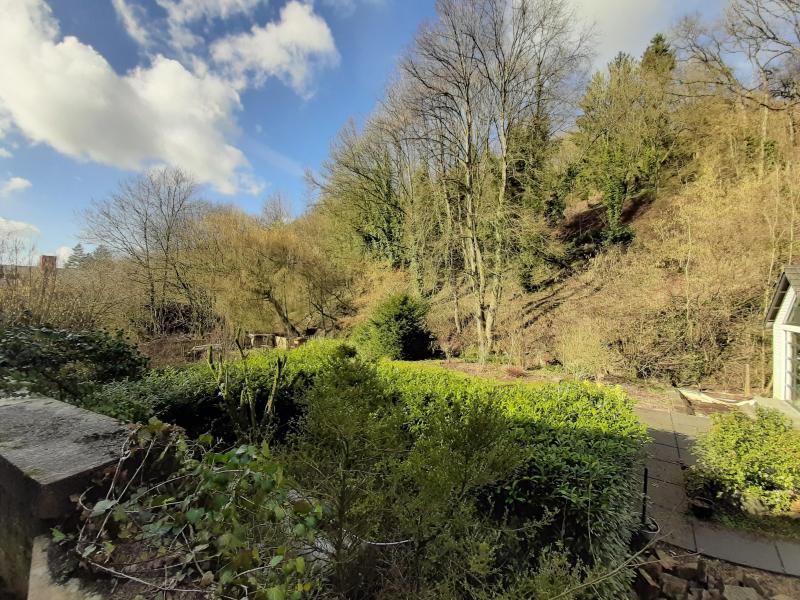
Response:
[0,0,800,388]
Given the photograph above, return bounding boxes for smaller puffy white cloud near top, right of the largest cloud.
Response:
[211,0,339,95]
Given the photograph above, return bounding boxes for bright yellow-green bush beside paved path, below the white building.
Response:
[692,407,800,514]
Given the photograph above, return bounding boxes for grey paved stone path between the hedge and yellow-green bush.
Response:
[635,408,800,577]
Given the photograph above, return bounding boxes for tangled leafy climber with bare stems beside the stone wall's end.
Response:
[75,421,322,600]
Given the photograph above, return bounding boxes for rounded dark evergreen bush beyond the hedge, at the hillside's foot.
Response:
[353,294,434,360]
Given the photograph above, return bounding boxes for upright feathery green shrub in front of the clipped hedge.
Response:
[285,353,403,597]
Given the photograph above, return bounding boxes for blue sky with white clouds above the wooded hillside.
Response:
[0,0,722,256]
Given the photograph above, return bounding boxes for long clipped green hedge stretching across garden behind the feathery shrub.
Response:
[86,341,646,598]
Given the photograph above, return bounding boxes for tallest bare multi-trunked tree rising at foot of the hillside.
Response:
[402,0,589,358]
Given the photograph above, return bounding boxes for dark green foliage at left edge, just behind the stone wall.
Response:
[0,325,147,401]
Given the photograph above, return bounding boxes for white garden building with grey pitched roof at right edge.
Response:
[767,265,800,408]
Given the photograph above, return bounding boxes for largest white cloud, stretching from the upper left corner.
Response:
[0,0,248,193]
